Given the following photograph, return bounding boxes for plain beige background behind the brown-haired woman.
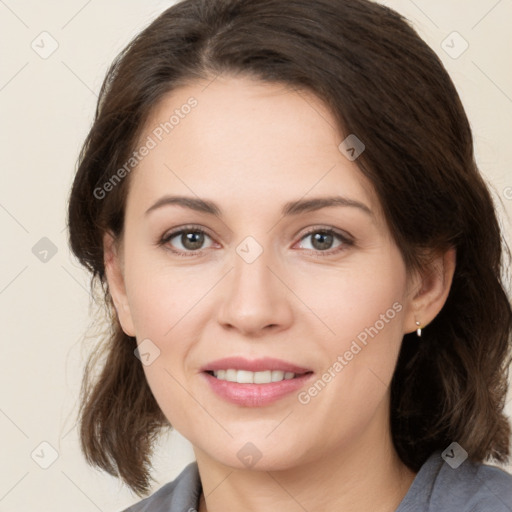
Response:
[0,0,512,512]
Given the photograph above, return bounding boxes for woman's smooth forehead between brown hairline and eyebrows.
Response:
[126,77,375,218]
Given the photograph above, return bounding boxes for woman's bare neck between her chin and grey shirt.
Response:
[194,400,416,512]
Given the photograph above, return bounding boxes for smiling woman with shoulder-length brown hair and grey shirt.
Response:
[69,0,512,512]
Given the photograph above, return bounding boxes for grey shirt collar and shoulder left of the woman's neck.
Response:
[123,462,202,512]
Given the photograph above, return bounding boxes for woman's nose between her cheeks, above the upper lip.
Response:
[218,246,293,337]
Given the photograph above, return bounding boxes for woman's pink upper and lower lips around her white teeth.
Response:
[201,357,313,407]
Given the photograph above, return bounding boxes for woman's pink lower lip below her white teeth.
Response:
[203,372,313,407]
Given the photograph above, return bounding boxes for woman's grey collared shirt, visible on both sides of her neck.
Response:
[123,451,512,512]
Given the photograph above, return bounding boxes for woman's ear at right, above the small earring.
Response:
[404,248,456,333]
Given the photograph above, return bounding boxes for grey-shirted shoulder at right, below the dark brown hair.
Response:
[397,451,512,512]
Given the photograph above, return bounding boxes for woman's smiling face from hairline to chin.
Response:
[107,78,420,469]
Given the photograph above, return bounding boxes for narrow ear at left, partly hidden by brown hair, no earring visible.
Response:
[103,232,135,336]
